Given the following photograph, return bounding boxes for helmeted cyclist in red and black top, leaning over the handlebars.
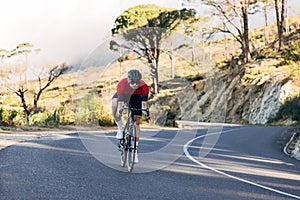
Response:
[112,69,149,162]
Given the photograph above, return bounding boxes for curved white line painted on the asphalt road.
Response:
[183,129,300,199]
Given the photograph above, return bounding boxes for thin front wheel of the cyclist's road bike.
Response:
[127,125,136,172]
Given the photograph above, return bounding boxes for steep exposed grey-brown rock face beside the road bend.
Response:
[154,60,300,124]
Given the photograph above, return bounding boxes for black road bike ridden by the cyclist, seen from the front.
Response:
[119,107,149,172]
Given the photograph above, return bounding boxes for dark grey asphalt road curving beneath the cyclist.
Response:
[0,126,300,200]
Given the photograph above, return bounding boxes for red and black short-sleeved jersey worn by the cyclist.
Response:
[117,78,149,102]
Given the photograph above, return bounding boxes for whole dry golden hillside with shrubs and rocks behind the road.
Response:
[0,16,300,130]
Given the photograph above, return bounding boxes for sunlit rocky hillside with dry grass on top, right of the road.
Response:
[153,30,300,125]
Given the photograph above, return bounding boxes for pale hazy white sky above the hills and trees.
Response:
[0,0,299,66]
